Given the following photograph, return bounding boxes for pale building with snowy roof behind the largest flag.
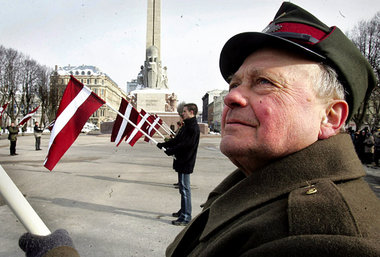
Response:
[56,65,127,127]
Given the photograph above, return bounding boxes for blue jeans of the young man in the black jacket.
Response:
[178,172,191,221]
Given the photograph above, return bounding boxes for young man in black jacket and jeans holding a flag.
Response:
[157,103,200,226]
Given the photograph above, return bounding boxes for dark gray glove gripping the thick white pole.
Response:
[18,229,74,257]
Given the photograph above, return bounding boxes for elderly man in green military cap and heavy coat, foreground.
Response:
[16,2,380,257]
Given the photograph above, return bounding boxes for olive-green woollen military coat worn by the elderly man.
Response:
[166,135,380,257]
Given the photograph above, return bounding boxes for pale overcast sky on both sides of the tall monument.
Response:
[0,0,380,108]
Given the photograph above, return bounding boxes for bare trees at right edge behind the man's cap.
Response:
[348,12,380,129]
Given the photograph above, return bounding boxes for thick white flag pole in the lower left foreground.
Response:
[0,165,51,236]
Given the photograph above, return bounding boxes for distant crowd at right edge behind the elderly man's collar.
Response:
[348,127,380,167]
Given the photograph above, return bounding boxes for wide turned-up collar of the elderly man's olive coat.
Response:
[200,134,365,240]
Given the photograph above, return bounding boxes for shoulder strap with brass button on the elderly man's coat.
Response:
[288,179,360,236]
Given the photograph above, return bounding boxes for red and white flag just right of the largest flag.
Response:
[111,98,141,146]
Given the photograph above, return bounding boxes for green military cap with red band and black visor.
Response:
[219,2,376,120]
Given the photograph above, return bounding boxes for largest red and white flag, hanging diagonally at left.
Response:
[44,76,105,171]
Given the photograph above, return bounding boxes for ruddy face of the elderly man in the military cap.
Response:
[220,49,326,174]
